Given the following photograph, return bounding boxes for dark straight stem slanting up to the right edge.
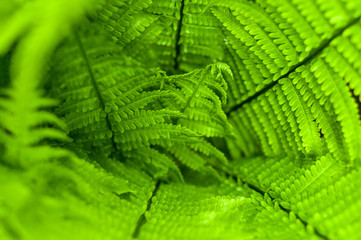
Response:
[226,17,361,116]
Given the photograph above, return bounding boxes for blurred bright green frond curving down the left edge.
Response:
[0,0,104,167]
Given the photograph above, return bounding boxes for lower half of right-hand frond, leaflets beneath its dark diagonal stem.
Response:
[225,18,360,164]
